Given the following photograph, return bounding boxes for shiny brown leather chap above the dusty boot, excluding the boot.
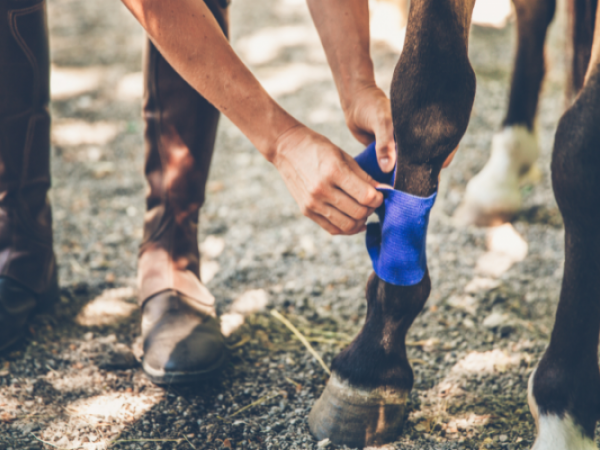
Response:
[138,0,227,314]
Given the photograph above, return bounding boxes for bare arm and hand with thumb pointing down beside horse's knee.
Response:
[307,0,396,172]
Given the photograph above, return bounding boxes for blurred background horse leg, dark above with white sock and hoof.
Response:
[456,0,556,226]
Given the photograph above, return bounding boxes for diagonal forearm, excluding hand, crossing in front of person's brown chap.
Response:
[123,0,300,161]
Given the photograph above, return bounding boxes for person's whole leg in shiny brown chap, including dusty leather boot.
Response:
[138,0,228,385]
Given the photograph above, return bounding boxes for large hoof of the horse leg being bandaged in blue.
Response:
[308,374,408,448]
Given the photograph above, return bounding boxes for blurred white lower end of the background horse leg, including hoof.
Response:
[456,125,539,225]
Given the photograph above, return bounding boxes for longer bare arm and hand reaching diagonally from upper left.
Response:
[123,0,383,234]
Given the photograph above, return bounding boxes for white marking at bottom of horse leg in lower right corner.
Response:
[527,370,598,450]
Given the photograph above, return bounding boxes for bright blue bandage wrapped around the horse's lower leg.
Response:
[355,143,437,286]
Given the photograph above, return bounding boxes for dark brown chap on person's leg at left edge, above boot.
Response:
[0,0,57,349]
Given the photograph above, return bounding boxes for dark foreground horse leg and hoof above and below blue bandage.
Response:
[309,0,475,447]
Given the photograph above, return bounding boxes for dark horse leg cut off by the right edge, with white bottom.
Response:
[529,6,600,450]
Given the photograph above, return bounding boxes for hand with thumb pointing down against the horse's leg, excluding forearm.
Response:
[342,86,396,173]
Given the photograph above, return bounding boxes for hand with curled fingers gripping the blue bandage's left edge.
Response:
[272,125,383,235]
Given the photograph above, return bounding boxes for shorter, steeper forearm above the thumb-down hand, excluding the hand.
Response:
[307,0,375,111]
